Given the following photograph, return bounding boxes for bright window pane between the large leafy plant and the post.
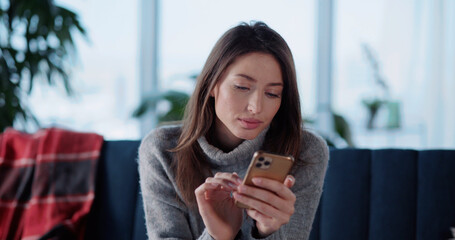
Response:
[29,0,140,139]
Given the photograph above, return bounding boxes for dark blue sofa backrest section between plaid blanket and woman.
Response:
[85,141,147,240]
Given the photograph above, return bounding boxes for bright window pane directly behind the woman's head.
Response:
[159,0,315,115]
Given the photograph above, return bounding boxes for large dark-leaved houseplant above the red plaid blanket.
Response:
[0,0,86,131]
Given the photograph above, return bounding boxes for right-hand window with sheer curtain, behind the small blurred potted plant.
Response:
[333,0,455,148]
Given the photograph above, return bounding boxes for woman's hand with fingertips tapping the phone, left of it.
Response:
[194,173,243,240]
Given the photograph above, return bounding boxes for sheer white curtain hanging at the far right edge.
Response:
[410,0,455,148]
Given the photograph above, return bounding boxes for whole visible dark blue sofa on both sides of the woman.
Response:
[86,141,455,240]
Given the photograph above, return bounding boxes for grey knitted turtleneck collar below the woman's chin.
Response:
[197,127,269,166]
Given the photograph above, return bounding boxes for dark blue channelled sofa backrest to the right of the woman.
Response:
[310,149,455,240]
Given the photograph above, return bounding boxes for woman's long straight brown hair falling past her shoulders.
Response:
[171,22,302,207]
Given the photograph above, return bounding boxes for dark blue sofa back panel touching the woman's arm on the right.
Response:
[319,149,371,240]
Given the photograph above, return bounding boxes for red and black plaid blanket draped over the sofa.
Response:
[0,128,103,240]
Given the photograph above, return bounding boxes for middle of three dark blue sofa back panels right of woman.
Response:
[369,150,417,240]
